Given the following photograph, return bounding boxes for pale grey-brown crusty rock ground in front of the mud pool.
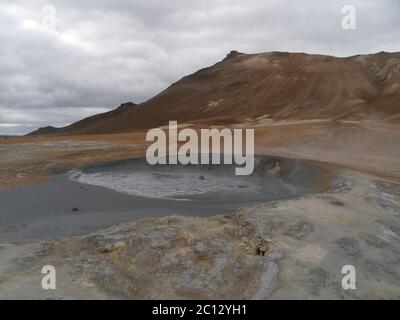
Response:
[0,170,400,299]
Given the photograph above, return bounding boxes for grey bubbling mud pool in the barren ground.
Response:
[0,156,330,239]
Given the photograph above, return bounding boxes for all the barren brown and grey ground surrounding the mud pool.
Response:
[0,120,400,299]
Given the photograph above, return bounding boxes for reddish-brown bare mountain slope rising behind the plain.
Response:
[31,51,400,134]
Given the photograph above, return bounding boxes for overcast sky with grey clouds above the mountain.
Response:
[0,0,400,134]
